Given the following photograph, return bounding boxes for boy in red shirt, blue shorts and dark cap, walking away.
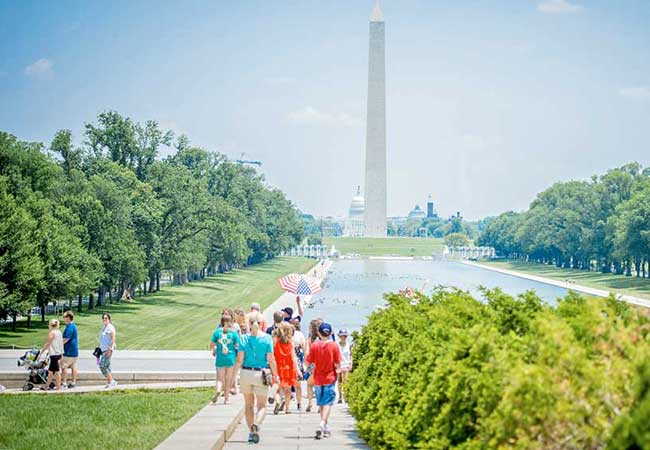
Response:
[307,323,341,439]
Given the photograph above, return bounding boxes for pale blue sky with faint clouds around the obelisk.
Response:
[0,0,650,219]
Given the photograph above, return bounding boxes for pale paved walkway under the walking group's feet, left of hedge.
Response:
[224,404,370,450]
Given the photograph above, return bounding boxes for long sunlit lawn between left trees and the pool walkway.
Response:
[0,258,314,350]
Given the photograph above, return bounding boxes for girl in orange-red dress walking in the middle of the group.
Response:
[273,322,298,414]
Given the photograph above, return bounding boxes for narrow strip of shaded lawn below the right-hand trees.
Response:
[481,261,650,299]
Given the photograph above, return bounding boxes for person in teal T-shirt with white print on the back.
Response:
[210,315,241,405]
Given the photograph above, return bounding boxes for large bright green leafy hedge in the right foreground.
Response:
[347,289,650,449]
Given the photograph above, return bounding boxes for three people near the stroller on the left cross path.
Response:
[39,311,117,390]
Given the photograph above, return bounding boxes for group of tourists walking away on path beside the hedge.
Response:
[210,296,352,443]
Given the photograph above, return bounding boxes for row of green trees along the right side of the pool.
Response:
[479,163,650,277]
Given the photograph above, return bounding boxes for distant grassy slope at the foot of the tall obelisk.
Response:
[324,237,445,256]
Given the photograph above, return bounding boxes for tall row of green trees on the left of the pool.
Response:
[0,111,303,327]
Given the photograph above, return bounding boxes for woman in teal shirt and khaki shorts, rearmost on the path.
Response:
[235,311,280,444]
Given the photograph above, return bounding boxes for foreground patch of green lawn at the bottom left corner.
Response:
[0,388,212,450]
